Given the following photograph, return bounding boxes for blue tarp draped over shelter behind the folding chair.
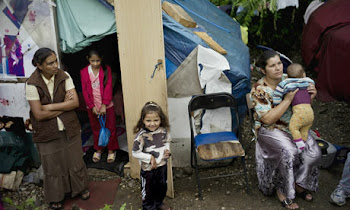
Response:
[163,0,250,115]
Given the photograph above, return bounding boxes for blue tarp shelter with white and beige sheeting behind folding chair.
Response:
[163,0,250,167]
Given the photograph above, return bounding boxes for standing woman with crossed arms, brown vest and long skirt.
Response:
[26,48,90,209]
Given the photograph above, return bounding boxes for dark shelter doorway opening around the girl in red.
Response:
[61,33,128,152]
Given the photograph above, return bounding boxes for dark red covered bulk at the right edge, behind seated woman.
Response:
[301,0,350,103]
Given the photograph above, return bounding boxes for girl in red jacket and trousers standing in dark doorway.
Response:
[80,50,119,163]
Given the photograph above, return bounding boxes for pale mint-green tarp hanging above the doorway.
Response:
[57,0,117,53]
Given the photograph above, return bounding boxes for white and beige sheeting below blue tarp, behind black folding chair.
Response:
[168,45,232,139]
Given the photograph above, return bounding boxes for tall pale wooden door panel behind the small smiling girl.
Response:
[114,0,174,197]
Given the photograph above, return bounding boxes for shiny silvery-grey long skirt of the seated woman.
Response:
[255,127,321,199]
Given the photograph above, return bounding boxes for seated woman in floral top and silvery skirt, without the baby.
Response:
[251,51,321,209]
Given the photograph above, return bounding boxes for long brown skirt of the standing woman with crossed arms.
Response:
[37,131,88,203]
